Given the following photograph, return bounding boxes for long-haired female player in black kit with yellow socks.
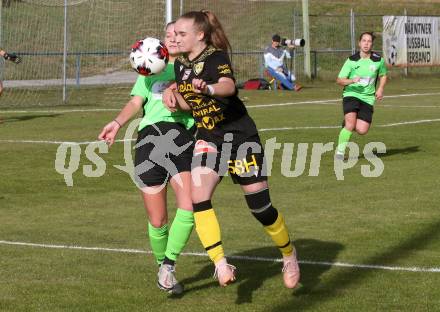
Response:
[164,11,300,288]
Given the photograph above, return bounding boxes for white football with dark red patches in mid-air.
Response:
[130,38,169,76]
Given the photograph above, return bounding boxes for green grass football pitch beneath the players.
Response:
[0,78,440,312]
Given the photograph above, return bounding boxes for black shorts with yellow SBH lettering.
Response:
[192,135,267,185]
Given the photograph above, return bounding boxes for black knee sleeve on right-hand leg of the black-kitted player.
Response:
[245,188,278,226]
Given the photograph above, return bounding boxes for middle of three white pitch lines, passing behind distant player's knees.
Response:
[0,119,440,145]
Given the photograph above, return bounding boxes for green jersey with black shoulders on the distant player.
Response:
[338,52,387,105]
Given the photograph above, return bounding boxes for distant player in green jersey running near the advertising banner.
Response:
[336,32,387,159]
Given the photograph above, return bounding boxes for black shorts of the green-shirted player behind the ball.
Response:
[134,122,194,187]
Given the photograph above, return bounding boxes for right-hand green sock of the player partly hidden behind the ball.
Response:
[165,208,194,261]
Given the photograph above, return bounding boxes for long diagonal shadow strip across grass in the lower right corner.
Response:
[272,221,440,312]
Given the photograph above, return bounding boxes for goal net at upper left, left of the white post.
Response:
[0,0,165,108]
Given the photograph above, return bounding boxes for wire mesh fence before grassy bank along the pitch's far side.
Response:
[0,0,440,105]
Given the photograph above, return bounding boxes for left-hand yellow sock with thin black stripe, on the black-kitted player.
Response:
[194,208,225,263]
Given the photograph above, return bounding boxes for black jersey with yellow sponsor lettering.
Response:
[174,46,257,148]
